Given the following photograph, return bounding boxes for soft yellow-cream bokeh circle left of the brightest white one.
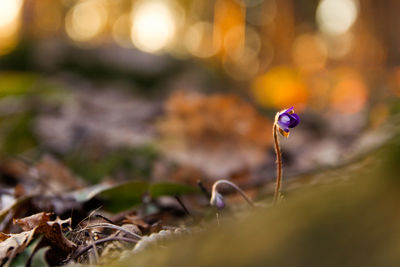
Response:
[65,0,107,42]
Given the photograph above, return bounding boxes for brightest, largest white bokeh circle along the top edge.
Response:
[131,0,177,53]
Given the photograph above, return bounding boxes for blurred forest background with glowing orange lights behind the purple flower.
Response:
[0,0,400,187]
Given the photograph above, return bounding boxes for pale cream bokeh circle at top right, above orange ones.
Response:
[316,0,358,35]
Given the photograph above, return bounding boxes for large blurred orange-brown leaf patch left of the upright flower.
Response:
[158,92,272,180]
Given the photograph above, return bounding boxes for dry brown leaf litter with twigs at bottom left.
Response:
[0,155,206,266]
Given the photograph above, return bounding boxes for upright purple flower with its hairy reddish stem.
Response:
[272,107,300,205]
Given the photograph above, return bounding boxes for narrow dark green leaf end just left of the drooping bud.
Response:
[149,182,198,198]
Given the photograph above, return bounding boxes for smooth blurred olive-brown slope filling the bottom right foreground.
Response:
[115,133,400,266]
